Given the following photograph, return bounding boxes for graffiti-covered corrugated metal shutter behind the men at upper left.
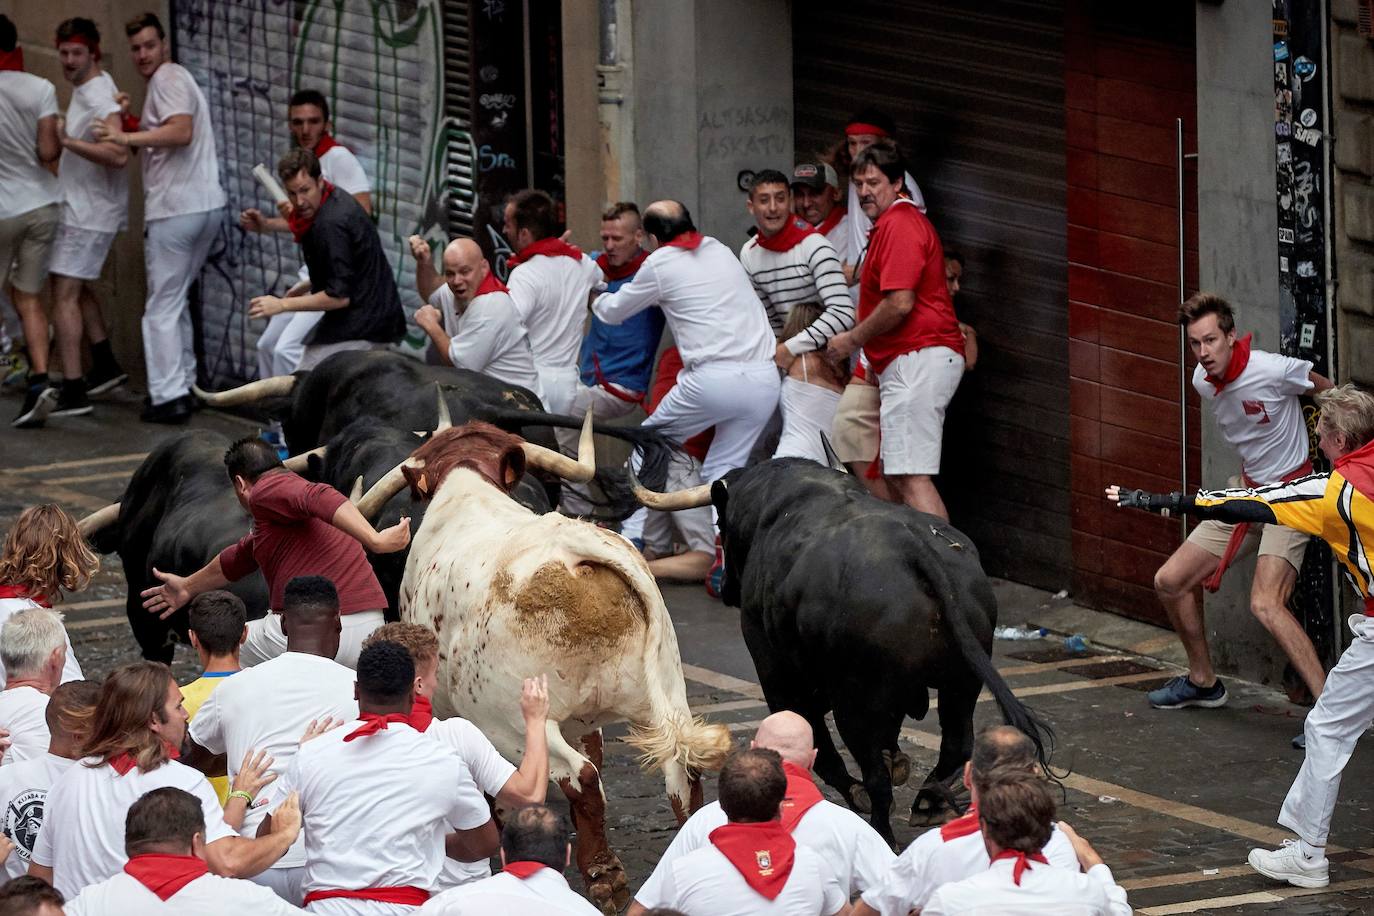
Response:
[172,0,458,383]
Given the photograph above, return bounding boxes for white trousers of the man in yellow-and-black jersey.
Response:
[1279,614,1374,846]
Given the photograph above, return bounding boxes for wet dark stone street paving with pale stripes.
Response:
[0,384,1374,915]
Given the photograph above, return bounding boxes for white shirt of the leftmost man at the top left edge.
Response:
[0,70,62,220]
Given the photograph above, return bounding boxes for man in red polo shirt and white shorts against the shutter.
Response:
[827,141,963,519]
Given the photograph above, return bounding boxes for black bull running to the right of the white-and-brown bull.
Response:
[712,459,1052,842]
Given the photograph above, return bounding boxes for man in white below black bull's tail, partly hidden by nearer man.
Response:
[855,725,1079,916]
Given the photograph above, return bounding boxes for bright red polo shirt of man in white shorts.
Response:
[859,198,963,372]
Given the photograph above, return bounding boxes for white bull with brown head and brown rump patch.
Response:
[359,415,731,912]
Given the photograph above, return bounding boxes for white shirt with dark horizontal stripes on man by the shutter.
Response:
[739,232,855,356]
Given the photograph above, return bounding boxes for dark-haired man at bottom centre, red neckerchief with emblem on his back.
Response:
[648,747,849,916]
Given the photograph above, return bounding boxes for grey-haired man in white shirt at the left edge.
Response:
[0,607,67,768]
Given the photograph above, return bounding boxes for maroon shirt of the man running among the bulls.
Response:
[220,470,386,614]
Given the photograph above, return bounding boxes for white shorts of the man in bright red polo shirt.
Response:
[878,346,963,477]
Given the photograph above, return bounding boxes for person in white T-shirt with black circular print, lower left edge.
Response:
[0,681,100,878]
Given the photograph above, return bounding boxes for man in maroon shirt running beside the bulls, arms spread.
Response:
[143,437,411,667]
